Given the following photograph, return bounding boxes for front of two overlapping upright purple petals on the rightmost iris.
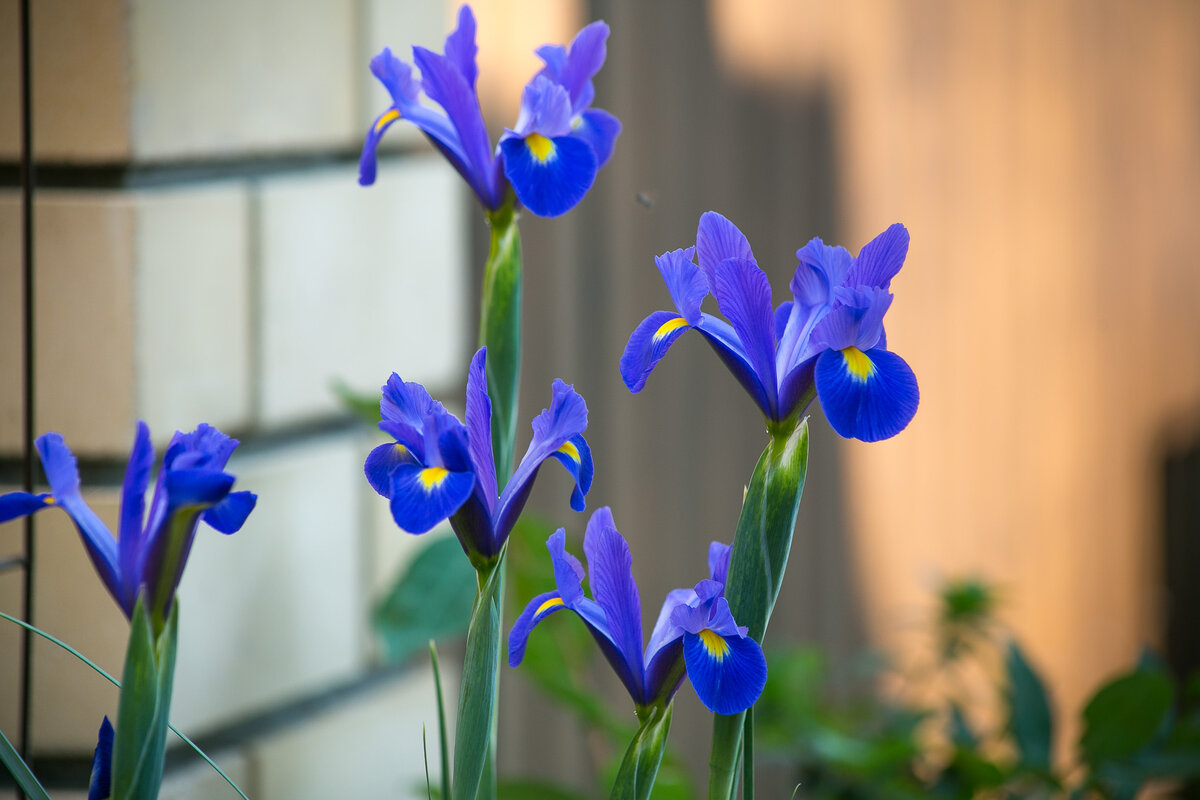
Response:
[710,258,779,419]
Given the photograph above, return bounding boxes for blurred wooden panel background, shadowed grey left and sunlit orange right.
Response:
[468,0,1200,780]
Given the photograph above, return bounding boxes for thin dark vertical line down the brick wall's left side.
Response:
[17,0,34,782]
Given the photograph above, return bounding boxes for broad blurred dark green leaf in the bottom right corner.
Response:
[1080,672,1175,768]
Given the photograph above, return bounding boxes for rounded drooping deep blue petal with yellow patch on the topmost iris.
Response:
[500,134,598,217]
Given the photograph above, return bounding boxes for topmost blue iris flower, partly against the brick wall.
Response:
[359,6,620,217]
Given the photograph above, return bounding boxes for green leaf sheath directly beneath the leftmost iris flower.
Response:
[112,596,179,800]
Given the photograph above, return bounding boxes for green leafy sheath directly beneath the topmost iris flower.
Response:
[479,203,521,487]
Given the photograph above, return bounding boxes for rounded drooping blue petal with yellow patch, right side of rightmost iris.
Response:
[815,348,920,441]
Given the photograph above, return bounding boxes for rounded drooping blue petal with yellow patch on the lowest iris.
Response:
[683,628,767,714]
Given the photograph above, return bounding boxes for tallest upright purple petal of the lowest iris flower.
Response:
[583,506,646,703]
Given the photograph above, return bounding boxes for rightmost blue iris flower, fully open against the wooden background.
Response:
[620,211,919,441]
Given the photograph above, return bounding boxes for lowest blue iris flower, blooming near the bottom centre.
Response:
[509,507,767,714]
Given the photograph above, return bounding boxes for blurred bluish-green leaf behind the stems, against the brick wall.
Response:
[371,536,475,663]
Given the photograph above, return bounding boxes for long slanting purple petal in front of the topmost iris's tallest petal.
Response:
[413,47,503,210]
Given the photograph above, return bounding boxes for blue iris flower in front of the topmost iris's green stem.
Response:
[364,348,593,559]
